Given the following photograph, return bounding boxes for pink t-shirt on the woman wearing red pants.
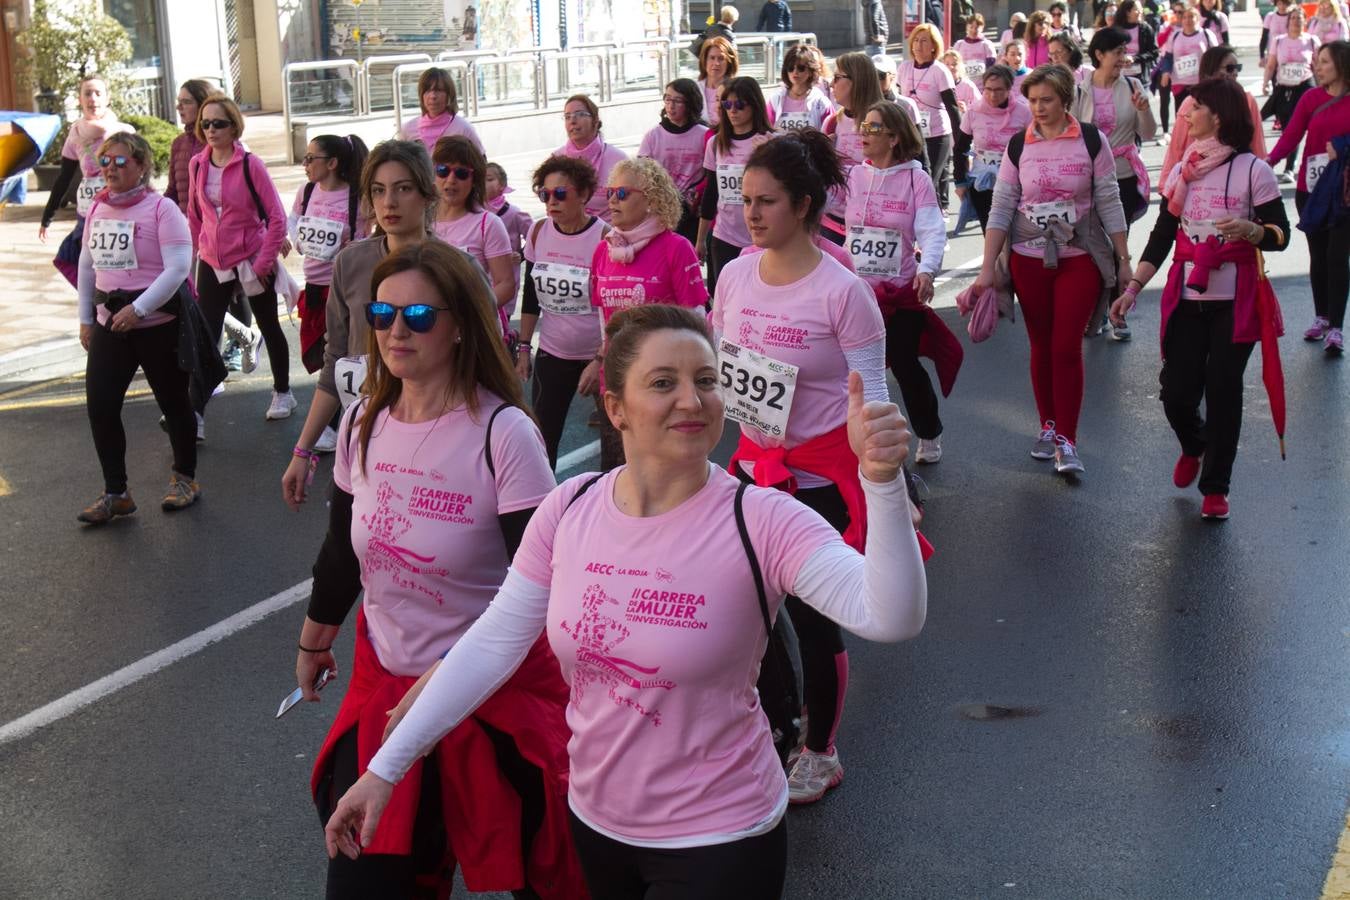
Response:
[999,118,1115,259]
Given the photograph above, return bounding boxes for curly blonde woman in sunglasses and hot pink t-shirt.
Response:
[596,159,712,472]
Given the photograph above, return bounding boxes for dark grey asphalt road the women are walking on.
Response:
[0,112,1350,899]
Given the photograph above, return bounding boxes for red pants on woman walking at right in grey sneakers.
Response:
[1011,252,1102,443]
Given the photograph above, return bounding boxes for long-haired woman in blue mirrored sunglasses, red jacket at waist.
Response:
[296,240,585,896]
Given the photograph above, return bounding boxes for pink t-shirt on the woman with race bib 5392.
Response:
[711,255,886,447]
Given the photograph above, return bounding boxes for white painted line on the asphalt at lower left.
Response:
[0,579,313,746]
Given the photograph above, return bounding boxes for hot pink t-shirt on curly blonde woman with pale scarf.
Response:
[591,231,707,322]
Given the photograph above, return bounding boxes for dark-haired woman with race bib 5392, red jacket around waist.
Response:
[711,130,890,803]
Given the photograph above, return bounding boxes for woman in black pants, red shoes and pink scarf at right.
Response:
[1111,78,1289,519]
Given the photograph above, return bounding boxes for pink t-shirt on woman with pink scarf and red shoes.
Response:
[1173,154,1280,300]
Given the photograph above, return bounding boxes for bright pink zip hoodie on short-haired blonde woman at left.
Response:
[188,142,286,278]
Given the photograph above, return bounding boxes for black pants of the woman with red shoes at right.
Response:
[1158,300,1256,495]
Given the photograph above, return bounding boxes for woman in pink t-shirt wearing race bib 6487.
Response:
[844,100,960,463]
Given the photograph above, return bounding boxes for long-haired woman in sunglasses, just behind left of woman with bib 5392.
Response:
[694,77,774,293]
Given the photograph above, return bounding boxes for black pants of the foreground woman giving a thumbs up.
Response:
[568,812,787,900]
